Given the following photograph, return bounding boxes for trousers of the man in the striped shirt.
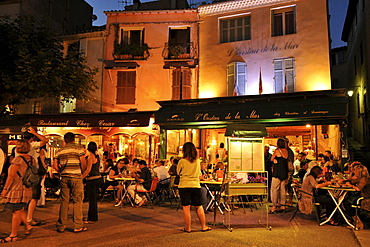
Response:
[57,177,84,230]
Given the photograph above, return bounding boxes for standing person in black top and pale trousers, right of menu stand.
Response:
[269,138,288,214]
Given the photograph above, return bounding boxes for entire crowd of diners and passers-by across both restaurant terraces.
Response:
[0,132,370,243]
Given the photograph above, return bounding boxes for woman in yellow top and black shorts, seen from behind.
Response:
[177,142,212,233]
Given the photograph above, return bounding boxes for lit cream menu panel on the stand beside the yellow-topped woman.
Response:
[229,138,265,172]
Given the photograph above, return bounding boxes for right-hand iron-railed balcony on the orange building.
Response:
[162,42,197,60]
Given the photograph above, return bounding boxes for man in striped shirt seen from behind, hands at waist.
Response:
[53,132,87,233]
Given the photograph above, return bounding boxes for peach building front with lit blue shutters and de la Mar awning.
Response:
[156,0,347,162]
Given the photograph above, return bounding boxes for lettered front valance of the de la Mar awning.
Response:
[156,95,347,124]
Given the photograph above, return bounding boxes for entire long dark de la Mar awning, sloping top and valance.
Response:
[155,89,348,129]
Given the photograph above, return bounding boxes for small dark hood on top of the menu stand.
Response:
[225,124,267,137]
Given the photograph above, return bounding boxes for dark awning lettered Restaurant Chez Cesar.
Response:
[30,111,154,127]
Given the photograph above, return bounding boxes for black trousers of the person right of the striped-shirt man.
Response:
[86,178,101,221]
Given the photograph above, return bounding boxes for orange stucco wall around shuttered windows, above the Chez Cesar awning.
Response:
[103,10,198,111]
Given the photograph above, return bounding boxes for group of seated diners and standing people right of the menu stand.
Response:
[265,138,370,228]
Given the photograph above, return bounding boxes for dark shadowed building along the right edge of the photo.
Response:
[342,0,370,147]
